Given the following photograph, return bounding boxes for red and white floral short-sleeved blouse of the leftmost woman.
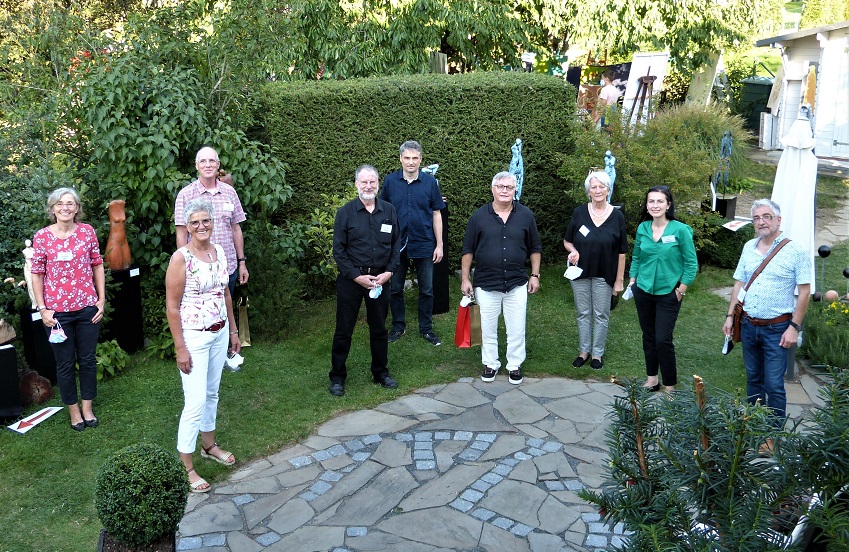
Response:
[32,223,103,312]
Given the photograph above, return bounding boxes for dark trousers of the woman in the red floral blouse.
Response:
[44,306,100,404]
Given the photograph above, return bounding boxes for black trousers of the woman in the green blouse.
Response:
[633,285,681,386]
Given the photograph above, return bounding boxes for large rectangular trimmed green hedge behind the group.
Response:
[257,72,575,265]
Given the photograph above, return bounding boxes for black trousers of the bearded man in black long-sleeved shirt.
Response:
[330,276,390,383]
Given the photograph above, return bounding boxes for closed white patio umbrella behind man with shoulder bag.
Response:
[772,107,817,293]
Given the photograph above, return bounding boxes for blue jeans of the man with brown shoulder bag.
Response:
[741,317,790,426]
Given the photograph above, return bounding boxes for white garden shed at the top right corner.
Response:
[755,21,849,160]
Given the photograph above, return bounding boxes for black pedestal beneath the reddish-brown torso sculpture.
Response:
[102,267,144,353]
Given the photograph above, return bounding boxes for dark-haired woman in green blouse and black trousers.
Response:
[628,186,699,391]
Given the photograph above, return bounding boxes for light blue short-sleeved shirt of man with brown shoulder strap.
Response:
[734,234,811,320]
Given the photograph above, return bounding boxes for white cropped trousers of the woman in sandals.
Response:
[177,324,230,454]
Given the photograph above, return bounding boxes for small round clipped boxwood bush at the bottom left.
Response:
[94,443,189,552]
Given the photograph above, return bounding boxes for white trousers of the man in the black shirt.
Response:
[475,285,528,371]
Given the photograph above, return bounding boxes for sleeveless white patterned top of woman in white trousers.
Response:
[178,243,230,330]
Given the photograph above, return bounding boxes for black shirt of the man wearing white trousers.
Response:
[463,201,542,293]
